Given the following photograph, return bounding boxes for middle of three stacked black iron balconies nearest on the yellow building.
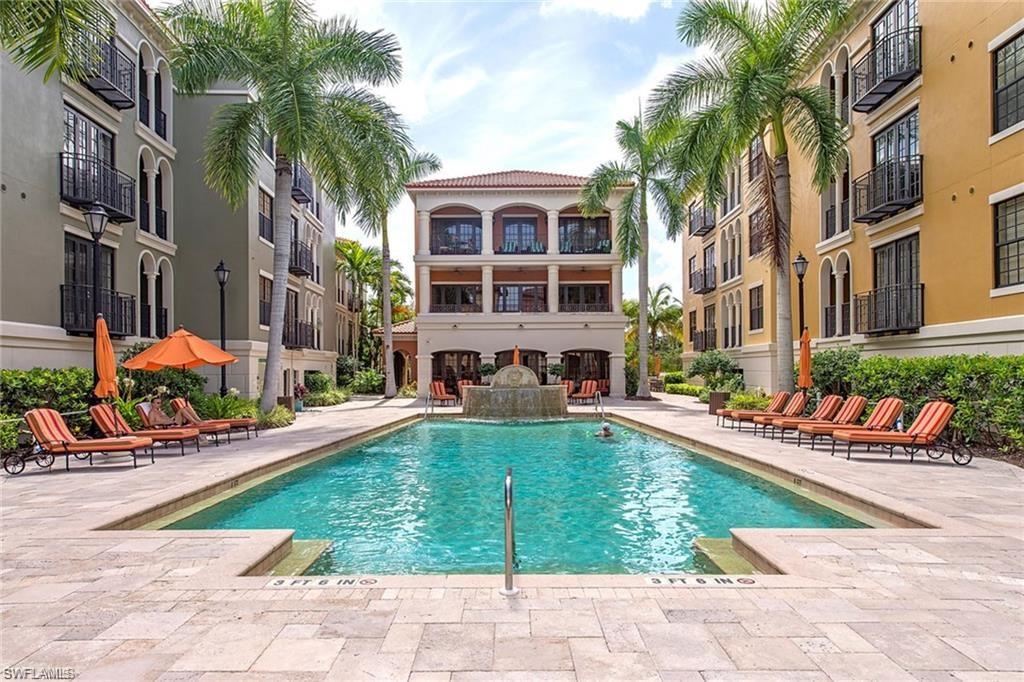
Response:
[853,154,925,223]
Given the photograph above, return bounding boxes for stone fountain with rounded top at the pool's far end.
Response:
[462,365,568,419]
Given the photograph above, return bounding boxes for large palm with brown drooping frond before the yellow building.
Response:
[648,0,851,390]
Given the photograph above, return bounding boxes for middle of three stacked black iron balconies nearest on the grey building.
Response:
[60,152,135,222]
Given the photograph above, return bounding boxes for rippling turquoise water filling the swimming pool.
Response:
[169,421,862,574]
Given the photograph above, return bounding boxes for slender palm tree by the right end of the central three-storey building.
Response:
[580,116,683,398]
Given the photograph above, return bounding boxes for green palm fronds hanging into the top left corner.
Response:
[0,0,114,83]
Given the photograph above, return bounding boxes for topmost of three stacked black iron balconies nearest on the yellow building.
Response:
[853,26,921,114]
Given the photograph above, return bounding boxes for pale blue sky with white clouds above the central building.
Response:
[325,0,694,297]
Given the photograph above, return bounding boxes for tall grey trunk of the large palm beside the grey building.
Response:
[259,154,292,412]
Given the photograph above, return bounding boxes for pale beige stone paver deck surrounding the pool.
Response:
[0,395,1024,680]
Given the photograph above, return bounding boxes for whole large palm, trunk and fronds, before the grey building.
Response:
[164,0,409,411]
